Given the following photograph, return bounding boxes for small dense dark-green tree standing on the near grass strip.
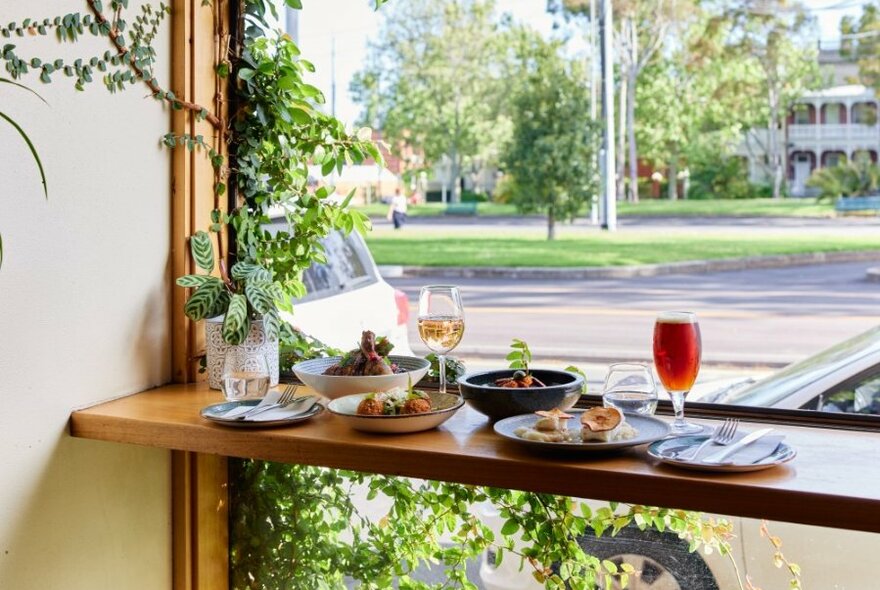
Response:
[503,35,596,240]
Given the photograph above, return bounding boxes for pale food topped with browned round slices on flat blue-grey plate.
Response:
[513,408,638,444]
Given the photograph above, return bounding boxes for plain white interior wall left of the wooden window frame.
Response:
[0,0,171,590]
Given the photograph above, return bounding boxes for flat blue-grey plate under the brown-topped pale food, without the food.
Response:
[494,410,669,453]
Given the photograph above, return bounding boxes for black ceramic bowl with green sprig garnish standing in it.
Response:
[458,369,584,420]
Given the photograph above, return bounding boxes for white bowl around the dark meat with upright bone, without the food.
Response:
[293,354,431,399]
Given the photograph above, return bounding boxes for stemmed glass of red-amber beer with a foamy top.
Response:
[654,311,703,434]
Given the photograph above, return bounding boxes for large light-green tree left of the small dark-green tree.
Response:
[352,0,508,200]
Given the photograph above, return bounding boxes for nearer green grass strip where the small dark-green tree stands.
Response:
[367,232,880,267]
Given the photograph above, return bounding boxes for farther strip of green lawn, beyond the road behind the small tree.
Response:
[359,199,834,217]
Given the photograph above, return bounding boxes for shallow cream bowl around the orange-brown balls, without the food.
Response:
[327,391,464,434]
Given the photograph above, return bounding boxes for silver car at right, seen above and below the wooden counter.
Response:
[480,326,880,590]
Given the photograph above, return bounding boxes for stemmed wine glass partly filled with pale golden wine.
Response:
[419,285,464,393]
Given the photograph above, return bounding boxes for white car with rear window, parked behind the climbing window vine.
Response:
[283,227,412,355]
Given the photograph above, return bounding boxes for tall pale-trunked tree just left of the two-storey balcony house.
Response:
[715,0,819,199]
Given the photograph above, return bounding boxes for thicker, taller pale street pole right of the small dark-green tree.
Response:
[599,0,617,231]
